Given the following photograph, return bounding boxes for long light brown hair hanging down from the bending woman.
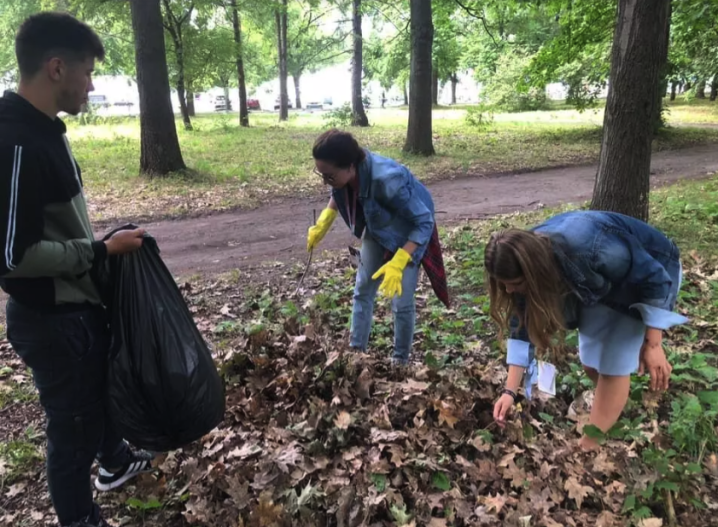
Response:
[484,229,570,356]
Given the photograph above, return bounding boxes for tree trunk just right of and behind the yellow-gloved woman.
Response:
[404,0,434,156]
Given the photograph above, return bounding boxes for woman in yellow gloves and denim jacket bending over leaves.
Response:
[307,130,448,364]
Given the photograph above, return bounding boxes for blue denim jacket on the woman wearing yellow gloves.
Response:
[332,150,434,265]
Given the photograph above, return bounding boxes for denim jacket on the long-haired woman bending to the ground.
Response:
[507,211,687,380]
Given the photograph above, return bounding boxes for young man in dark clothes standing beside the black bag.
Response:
[0,13,152,527]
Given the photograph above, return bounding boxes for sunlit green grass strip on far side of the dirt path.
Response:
[69,102,718,220]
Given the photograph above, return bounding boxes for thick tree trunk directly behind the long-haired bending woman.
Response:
[591,0,670,220]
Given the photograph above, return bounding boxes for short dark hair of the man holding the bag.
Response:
[15,12,105,77]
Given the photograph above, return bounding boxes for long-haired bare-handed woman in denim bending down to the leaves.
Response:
[485,211,687,448]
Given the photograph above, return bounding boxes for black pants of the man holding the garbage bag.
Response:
[7,300,130,526]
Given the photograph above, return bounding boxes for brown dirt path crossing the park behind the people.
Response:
[138,145,718,274]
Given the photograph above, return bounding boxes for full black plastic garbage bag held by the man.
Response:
[100,225,225,452]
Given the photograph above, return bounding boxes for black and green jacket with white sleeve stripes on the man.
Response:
[0,92,107,311]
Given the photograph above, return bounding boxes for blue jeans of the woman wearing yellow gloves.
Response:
[351,233,419,364]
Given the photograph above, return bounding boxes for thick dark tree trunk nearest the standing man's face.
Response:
[130,0,187,176]
